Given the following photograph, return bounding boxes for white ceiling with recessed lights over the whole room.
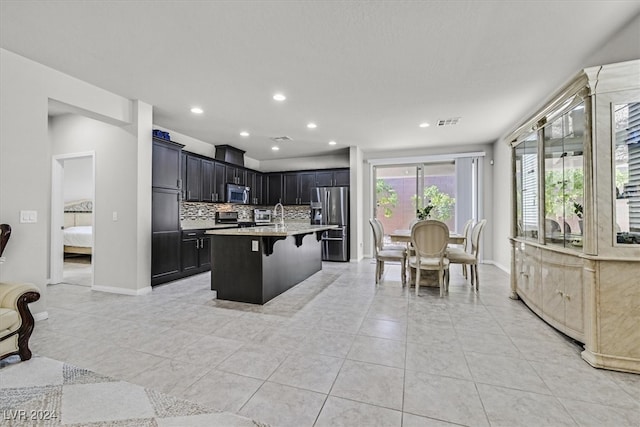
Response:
[0,0,640,160]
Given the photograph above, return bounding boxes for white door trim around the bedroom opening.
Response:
[49,151,96,287]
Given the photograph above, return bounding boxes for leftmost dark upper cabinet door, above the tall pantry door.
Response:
[151,138,183,190]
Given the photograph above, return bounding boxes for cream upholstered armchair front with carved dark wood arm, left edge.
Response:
[0,283,40,360]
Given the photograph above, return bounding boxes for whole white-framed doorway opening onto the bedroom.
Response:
[51,152,95,287]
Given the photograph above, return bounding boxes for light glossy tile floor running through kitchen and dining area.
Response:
[31,260,640,427]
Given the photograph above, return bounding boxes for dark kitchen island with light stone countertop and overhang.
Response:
[206,223,337,304]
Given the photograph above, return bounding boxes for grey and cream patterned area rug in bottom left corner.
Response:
[0,356,266,427]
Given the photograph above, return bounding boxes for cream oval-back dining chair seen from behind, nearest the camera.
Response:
[409,220,449,296]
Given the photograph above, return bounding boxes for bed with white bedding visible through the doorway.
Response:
[63,200,93,255]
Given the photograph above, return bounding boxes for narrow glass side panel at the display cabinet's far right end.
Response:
[613,102,640,245]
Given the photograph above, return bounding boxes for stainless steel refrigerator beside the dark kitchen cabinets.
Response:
[311,187,349,261]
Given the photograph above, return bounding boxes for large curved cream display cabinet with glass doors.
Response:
[507,60,640,373]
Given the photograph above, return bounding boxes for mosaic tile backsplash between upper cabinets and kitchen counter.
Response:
[180,202,310,221]
